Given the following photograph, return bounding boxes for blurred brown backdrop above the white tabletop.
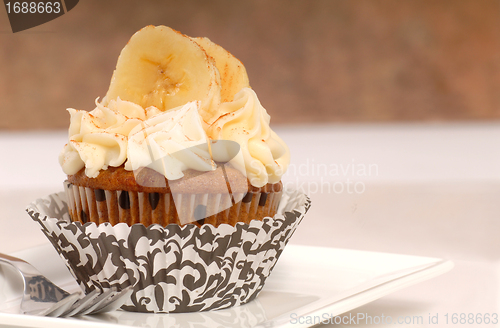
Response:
[0,0,500,130]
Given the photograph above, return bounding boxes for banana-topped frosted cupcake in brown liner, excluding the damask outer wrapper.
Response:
[59,26,289,226]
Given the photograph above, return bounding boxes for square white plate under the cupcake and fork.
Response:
[0,242,453,328]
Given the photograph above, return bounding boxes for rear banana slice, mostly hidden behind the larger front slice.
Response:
[193,38,250,102]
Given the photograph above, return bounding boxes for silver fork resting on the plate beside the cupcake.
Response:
[0,253,133,317]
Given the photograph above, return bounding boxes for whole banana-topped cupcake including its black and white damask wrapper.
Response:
[28,26,310,313]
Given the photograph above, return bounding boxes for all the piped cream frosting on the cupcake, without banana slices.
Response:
[59,88,290,187]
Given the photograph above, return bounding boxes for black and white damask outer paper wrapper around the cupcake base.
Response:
[27,191,311,313]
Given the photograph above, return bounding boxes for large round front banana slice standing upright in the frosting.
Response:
[103,26,221,112]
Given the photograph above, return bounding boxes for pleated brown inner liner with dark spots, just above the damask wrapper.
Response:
[64,182,282,227]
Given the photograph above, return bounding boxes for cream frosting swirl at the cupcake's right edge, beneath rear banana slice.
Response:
[207,88,290,187]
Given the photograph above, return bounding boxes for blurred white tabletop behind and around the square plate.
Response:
[0,124,500,328]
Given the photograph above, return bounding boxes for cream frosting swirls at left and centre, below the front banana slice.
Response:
[59,99,214,180]
